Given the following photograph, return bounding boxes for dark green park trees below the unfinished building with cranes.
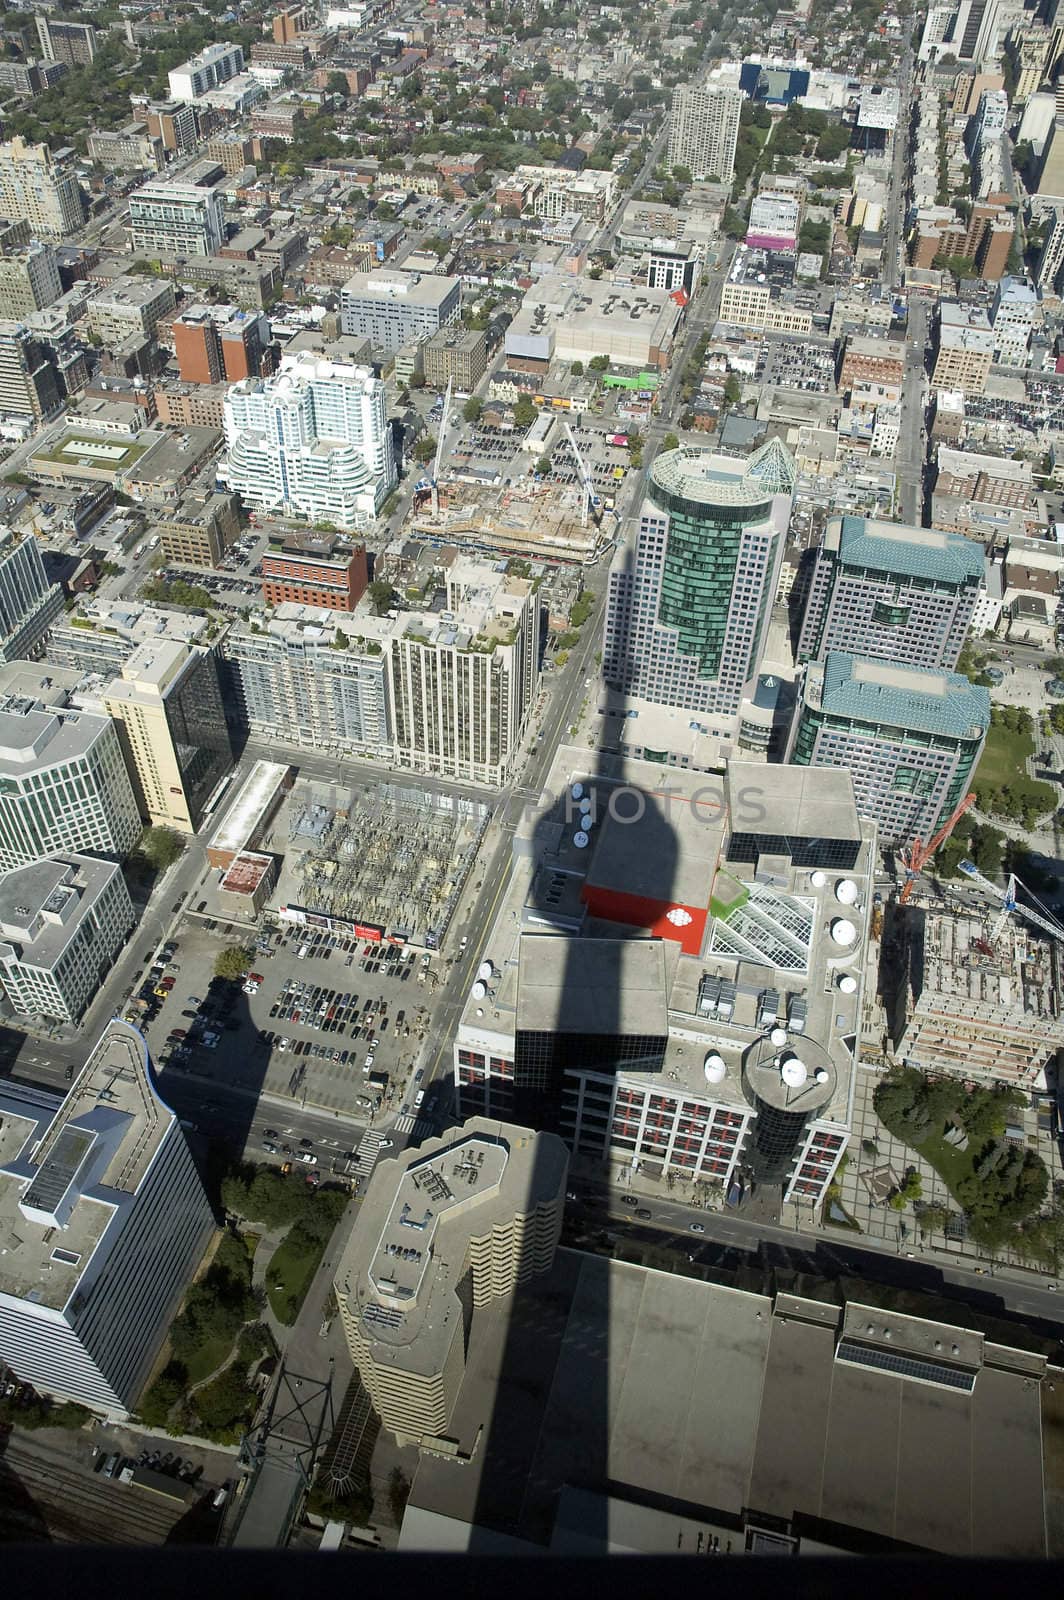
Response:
[875,1067,1050,1250]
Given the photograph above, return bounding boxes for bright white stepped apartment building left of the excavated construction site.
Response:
[222,357,397,528]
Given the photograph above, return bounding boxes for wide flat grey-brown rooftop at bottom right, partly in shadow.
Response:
[410,1250,1054,1557]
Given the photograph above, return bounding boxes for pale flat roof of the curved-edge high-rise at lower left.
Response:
[0,1021,174,1310]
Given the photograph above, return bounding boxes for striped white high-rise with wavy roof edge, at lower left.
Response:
[0,1021,214,1418]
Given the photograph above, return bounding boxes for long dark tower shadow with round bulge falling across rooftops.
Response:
[461,536,677,1554]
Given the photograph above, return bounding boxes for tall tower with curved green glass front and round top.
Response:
[603,440,795,715]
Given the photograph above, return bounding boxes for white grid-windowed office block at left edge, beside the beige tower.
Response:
[0,662,141,870]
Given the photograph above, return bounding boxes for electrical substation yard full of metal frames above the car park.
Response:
[273,782,488,950]
